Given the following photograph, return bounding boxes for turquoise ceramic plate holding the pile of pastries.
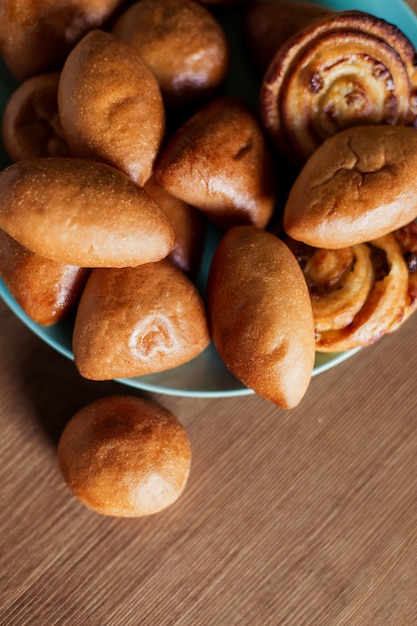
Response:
[0,0,417,398]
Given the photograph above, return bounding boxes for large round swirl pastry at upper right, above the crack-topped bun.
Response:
[260,11,417,165]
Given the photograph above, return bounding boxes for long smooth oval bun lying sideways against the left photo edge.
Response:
[0,157,174,267]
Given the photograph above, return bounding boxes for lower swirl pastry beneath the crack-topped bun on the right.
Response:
[291,233,409,352]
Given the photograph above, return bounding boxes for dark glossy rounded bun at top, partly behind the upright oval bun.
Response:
[112,0,229,107]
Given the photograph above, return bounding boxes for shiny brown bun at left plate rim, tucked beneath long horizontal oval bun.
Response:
[0,230,88,326]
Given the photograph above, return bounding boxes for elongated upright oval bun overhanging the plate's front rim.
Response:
[207,226,315,409]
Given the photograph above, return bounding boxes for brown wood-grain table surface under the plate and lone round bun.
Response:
[4,0,417,626]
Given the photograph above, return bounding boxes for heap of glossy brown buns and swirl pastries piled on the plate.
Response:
[0,0,417,408]
